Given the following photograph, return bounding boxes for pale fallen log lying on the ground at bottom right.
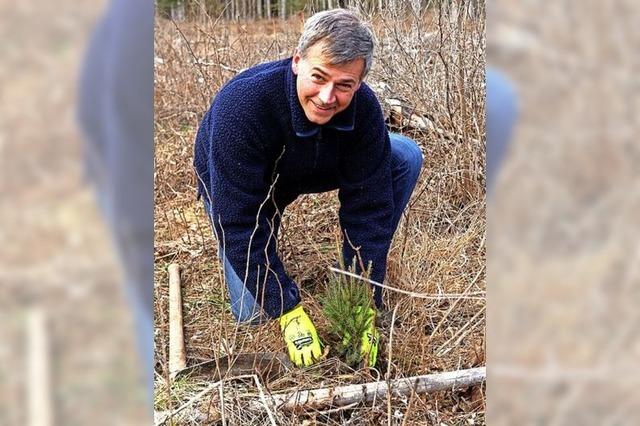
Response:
[271,367,487,411]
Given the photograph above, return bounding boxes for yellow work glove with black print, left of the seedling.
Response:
[280,305,322,367]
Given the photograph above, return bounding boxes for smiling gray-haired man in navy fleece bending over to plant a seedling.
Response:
[194,9,422,365]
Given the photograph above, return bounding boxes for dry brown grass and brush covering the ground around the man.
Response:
[154,2,486,425]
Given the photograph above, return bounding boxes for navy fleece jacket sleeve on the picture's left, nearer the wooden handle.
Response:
[198,88,300,318]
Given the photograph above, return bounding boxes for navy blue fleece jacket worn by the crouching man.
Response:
[194,58,394,318]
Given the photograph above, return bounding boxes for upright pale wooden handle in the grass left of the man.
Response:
[169,263,187,375]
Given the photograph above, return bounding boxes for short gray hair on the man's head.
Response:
[298,9,374,78]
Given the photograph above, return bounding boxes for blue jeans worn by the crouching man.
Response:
[203,133,424,325]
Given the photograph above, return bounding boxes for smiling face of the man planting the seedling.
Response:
[292,42,364,124]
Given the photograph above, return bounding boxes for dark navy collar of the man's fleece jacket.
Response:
[285,59,358,138]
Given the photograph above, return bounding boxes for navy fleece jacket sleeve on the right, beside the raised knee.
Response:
[338,87,394,308]
